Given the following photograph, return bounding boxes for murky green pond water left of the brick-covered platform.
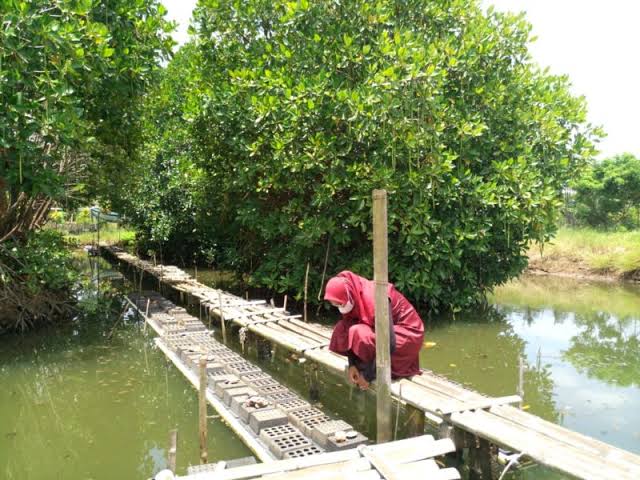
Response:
[0,258,251,480]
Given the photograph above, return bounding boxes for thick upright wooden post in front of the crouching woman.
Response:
[372,190,393,443]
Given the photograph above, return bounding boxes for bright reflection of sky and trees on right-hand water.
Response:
[492,277,640,453]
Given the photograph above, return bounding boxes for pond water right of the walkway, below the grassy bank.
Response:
[422,277,640,453]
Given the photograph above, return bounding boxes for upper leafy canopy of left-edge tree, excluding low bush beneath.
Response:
[0,0,171,239]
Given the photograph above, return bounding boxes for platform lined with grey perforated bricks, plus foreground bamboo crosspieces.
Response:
[127,292,460,480]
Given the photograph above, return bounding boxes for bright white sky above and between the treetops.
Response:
[162,0,640,158]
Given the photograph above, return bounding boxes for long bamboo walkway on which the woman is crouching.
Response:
[104,248,640,480]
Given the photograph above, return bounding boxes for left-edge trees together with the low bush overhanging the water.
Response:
[0,0,172,326]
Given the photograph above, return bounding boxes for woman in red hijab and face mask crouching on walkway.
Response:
[324,271,424,390]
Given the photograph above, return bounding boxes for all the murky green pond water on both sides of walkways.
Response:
[0,260,640,480]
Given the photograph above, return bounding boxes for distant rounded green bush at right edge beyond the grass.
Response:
[574,153,640,228]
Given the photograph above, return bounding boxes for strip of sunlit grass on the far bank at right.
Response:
[529,228,640,276]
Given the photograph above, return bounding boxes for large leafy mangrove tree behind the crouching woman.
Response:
[131,0,598,310]
